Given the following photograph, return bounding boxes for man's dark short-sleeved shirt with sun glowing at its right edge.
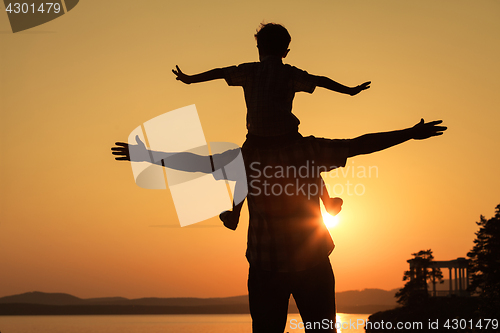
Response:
[242,136,350,272]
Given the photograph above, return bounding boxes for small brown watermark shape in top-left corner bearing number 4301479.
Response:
[3,0,79,33]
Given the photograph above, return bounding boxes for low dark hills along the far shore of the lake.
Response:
[0,289,397,315]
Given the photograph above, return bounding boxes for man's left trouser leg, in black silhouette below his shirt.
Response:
[248,267,290,333]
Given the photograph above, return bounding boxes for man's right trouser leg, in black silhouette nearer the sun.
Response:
[292,258,336,333]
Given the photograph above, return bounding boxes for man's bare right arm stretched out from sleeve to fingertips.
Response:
[349,119,447,157]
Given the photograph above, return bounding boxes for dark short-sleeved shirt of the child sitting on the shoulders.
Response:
[223,57,317,136]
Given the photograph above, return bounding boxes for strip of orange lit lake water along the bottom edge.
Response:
[0,313,369,333]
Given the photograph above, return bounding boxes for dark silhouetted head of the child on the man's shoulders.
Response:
[255,23,292,57]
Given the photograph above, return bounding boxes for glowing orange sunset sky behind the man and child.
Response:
[0,0,500,298]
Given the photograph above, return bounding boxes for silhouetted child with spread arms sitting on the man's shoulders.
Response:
[172,23,371,230]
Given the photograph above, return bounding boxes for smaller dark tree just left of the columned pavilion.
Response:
[396,249,443,307]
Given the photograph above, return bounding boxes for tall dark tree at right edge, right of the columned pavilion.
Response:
[467,205,500,318]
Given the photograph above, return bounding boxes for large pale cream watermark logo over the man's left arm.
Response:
[128,104,248,226]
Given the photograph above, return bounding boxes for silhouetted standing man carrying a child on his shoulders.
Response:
[112,119,446,333]
